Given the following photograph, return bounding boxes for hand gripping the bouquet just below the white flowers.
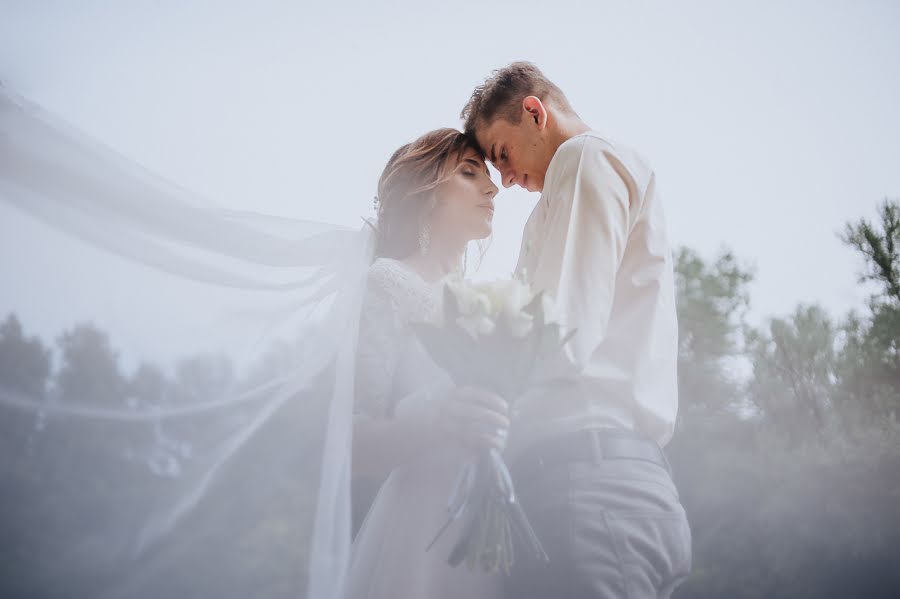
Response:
[437,387,509,450]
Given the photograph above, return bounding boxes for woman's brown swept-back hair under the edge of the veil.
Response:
[375,128,481,260]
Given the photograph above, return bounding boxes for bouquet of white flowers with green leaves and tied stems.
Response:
[415,279,575,573]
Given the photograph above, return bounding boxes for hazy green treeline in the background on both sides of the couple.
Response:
[0,200,900,599]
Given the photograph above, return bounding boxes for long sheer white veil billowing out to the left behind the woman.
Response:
[0,87,372,599]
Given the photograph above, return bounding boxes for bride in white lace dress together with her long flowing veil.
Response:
[0,87,509,599]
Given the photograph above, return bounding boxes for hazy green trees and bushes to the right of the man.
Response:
[668,201,900,599]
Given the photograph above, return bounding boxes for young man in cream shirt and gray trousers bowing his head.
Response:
[462,62,691,599]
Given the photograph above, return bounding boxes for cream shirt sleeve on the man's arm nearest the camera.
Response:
[532,136,636,366]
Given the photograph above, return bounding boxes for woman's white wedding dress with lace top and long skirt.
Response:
[345,258,502,599]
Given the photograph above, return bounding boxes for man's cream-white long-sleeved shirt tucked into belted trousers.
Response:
[507,131,678,453]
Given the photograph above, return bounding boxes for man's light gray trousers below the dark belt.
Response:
[506,452,691,599]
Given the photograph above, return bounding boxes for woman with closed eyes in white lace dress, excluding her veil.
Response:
[347,129,509,599]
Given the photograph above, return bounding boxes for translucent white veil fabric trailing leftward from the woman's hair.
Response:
[0,88,373,599]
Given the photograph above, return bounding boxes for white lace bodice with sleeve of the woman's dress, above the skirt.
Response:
[355,258,447,417]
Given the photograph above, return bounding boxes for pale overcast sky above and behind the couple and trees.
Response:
[0,0,900,368]
